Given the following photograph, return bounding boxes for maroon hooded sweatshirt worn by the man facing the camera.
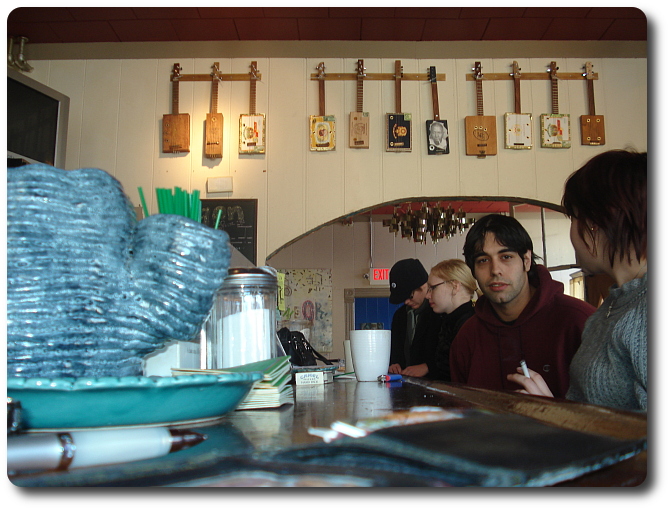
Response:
[450,265,595,398]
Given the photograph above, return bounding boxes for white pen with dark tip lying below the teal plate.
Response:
[7,427,207,472]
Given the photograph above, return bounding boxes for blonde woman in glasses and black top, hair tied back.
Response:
[402,259,478,381]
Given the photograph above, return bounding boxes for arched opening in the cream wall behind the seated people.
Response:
[266,197,583,357]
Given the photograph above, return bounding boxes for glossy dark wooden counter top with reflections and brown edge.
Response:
[11,378,647,487]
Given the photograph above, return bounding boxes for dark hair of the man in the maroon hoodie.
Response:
[463,214,539,282]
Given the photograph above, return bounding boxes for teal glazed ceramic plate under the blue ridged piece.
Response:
[7,372,263,430]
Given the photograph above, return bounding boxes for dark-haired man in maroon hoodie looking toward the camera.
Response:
[450,214,595,397]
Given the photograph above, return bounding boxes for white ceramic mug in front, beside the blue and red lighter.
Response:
[349,329,391,381]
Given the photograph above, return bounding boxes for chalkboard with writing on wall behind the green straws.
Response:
[201,198,258,265]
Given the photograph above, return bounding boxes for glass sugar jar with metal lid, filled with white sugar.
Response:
[205,268,277,369]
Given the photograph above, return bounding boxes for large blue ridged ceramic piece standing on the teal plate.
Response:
[7,164,231,378]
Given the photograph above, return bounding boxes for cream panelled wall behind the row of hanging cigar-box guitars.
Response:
[30,55,647,263]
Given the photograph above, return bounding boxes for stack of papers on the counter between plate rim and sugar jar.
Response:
[172,356,294,409]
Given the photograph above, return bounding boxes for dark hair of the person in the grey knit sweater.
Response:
[563,149,647,264]
